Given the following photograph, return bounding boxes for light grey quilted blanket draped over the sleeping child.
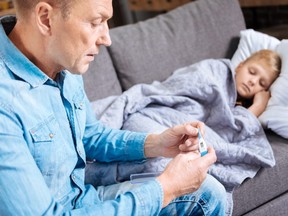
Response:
[87,59,275,214]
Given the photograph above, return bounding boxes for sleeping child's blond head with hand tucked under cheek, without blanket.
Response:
[235,50,281,117]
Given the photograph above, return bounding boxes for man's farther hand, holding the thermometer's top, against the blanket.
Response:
[144,122,204,157]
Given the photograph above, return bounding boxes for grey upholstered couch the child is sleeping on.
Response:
[84,0,288,216]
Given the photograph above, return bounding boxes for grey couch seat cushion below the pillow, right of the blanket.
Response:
[233,132,288,215]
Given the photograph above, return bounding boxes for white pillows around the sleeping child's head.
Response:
[231,29,288,138]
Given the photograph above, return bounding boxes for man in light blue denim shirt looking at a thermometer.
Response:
[0,0,226,216]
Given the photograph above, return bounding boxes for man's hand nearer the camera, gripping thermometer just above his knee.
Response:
[157,147,216,207]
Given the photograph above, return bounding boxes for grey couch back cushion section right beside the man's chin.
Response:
[83,46,122,101]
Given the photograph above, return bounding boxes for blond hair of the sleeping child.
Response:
[243,49,282,77]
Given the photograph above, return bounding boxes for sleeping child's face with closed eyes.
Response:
[235,60,276,99]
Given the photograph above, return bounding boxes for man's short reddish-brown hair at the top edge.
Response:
[13,0,76,18]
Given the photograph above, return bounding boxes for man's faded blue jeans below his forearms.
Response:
[96,175,226,216]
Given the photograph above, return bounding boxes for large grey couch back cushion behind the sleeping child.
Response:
[109,0,245,89]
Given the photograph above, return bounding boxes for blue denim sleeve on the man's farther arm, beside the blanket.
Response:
[83,100,147,162]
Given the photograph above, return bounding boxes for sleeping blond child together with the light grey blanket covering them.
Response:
[86,50,281,189]
